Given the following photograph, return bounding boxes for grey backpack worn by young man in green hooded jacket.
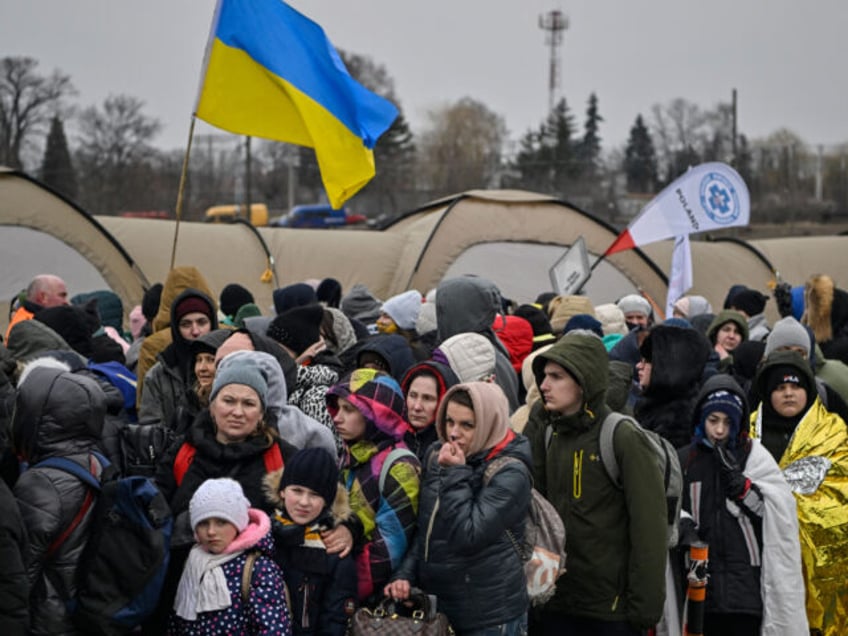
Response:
[545,412,683,548]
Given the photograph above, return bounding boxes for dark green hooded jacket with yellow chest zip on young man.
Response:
[524,334,667,629]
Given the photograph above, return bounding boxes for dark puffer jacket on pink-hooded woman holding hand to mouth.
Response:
[392,382,532,633]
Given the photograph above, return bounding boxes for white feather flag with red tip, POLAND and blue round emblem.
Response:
[604,162,751,256]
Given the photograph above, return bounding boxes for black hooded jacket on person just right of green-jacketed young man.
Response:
[633,325,710,448]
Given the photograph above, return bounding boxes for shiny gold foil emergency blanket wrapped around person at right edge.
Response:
[780,399,848,636]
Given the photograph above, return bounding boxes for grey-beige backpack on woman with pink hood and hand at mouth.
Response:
[483,455,565,605]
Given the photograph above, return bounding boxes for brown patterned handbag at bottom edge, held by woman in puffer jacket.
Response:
[348,587,454,636]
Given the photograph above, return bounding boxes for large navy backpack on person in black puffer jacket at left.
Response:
[36,452,173,634]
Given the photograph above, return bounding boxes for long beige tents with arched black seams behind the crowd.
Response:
[0,170,848,330]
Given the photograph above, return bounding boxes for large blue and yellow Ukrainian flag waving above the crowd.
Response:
[195,0,398,208]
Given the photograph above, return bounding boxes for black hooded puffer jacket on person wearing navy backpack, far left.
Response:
[12,360,106,634]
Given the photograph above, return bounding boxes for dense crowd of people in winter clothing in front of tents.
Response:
[0,267,848,636]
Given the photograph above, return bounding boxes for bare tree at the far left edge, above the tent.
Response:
[0,57,75,168]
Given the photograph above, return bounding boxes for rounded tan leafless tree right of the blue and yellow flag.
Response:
[419,97,507,195]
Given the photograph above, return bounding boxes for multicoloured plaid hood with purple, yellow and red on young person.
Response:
[327,369,408,441]
